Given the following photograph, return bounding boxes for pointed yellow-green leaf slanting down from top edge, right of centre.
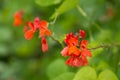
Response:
[50,0,79,19]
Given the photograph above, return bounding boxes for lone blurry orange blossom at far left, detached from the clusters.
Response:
[14,11,23,26]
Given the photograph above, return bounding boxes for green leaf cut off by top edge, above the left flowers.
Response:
[35,0,62,7]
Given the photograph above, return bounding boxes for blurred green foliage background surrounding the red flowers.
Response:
[0,0,120,80]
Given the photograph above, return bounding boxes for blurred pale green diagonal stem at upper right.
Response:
[76,5,102,31]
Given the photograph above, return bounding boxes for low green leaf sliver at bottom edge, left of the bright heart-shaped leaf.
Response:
[53,72,75,80]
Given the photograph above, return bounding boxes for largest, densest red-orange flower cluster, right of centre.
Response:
[61,30,92,67]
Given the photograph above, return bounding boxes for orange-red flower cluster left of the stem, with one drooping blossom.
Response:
[24,17,51,52]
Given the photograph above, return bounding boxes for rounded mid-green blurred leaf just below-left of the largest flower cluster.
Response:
[47,59,68,79]
